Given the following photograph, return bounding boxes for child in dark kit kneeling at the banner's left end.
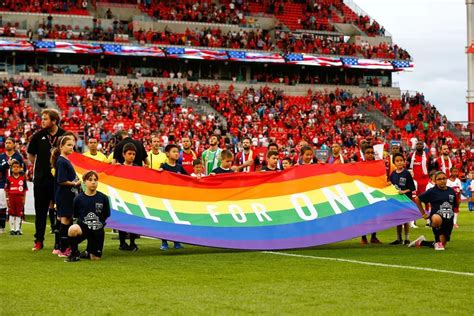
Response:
[65,170,110,262]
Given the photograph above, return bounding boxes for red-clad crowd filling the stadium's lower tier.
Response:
[0,75,471,175]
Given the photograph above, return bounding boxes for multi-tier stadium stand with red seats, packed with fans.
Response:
[0,0,470,175]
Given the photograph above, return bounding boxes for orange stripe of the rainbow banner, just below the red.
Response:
[76,166,387,201]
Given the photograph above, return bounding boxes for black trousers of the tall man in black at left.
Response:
[33,181,54,242]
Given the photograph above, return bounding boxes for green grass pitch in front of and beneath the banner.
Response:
[0,206,474,315]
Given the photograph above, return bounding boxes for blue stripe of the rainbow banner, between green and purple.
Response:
[108,200,420,241]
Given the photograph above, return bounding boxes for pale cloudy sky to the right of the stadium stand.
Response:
[355,0,467,121]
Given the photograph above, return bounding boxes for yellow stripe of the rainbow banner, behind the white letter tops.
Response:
[90,181,398,214]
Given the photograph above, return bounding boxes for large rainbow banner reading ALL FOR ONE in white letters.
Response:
[70,154,420,250]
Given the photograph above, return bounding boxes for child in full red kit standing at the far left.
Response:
[5,160,28,235]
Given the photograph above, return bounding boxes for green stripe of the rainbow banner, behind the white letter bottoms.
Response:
[110,190,409,227]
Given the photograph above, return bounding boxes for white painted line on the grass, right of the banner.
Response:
[262,251,474,277]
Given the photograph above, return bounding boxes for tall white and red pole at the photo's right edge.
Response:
[466,0,474,140]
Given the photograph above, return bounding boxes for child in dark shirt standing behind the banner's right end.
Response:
[390,153,416,245]
